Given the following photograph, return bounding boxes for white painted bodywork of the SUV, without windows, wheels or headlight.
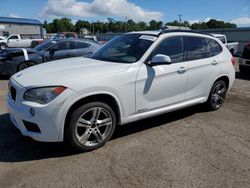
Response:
[7,32,235,142]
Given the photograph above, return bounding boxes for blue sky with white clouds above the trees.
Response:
[0,0,250,27]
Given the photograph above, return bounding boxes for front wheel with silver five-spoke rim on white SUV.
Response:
[65,102,116,152]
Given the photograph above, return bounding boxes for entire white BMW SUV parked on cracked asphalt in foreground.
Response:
[7,30,235,151]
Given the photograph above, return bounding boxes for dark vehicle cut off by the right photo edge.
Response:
[239,43,250,75]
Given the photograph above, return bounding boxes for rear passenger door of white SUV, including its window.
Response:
[185,37,221,100]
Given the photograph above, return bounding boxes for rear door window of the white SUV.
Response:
[187,37,213,61]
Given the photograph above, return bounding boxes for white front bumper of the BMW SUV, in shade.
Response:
[7,79,72,142]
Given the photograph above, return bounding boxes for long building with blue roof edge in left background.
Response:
[0,17,43,38]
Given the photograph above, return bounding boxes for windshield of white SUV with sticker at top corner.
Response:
[91,34,157,63]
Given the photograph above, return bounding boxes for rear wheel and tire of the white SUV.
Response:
[206,80,227,111]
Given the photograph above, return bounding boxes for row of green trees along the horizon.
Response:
[43,18,237,34]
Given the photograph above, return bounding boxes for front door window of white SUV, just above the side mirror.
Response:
[152,37,184,63]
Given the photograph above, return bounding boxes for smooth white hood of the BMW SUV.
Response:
[12,57,130,88]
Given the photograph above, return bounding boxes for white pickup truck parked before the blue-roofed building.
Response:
[0,34,43,50]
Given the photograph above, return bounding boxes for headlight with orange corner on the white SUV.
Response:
[23,86,66,104]
